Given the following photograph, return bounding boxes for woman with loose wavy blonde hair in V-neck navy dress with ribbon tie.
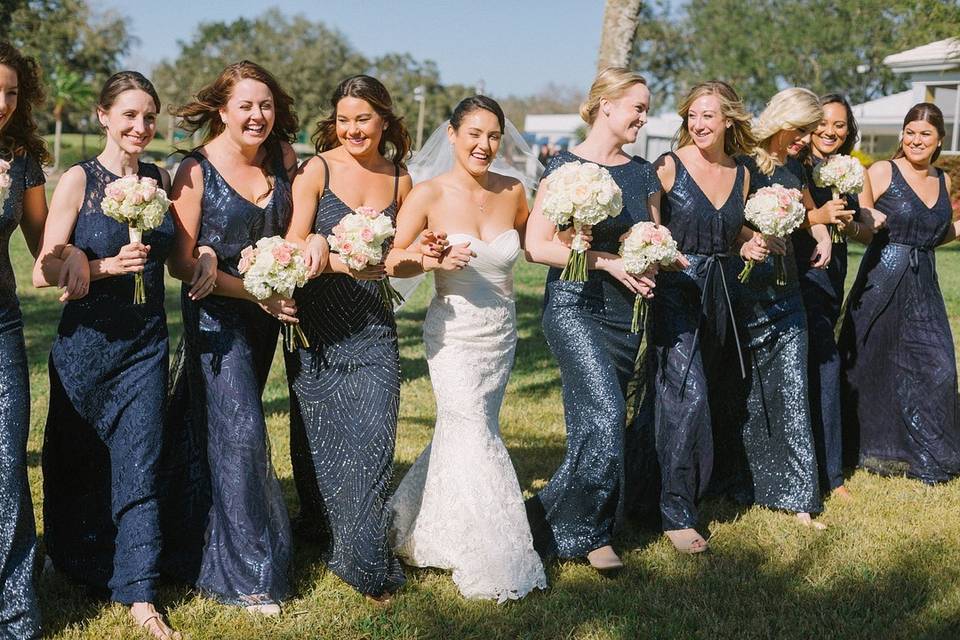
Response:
[651,81,766,553]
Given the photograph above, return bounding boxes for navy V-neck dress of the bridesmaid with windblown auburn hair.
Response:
[164,149,292,606]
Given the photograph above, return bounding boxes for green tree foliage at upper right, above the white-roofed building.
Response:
[633,0,960,109]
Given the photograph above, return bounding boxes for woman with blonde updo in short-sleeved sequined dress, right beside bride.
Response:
[525,67,660,570]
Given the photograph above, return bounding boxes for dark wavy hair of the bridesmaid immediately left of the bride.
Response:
[311,74,413,168]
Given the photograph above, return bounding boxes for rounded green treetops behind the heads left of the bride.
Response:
[153,9,473,152]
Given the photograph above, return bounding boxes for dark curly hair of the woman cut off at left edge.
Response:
[0,40,50,164]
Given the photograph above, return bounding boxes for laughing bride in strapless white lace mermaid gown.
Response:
[386,96,546,602]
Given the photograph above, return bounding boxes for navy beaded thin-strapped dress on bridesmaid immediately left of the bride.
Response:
[285,157,405,596]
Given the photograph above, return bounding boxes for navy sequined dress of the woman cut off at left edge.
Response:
[0,155,46,640]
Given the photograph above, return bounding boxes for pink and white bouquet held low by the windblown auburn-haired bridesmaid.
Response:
[237,236,310,351]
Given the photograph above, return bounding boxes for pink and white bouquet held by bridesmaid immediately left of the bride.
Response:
[327,207,403,309]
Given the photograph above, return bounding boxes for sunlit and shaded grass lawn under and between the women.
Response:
[13,231,960,640]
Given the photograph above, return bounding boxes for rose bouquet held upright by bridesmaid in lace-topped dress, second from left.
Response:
[101,175,170,304]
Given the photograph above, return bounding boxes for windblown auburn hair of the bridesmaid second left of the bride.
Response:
[171,60,300,171]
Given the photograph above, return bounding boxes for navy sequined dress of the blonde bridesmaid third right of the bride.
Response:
[731,157,822,513]
